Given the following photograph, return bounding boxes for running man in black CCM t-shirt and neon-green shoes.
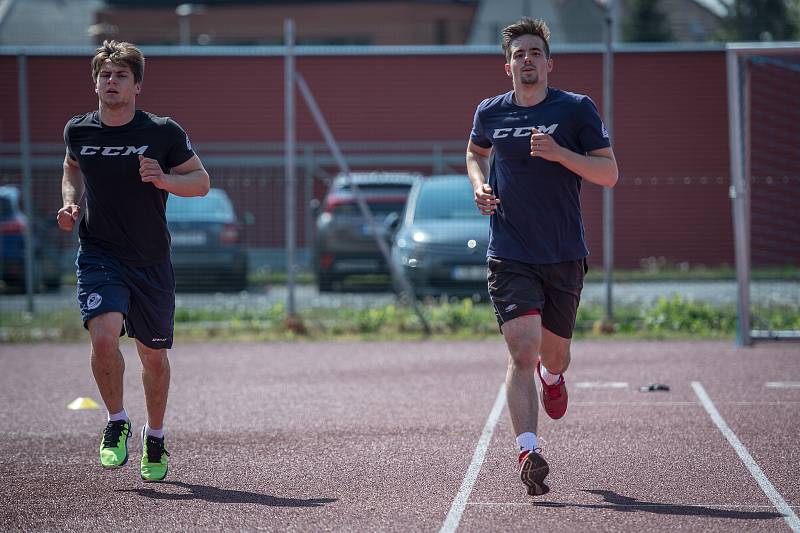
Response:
[58,41,210,481]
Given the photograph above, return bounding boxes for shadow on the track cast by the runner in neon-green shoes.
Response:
[115,481,336,507]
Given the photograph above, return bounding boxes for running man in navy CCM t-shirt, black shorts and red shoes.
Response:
[467,18,617,495]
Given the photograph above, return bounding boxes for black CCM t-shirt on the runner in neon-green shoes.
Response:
[64,110,195,267]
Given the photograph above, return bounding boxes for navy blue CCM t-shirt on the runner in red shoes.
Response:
[470,88,611,264]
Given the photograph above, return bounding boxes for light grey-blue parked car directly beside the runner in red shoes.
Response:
[392,175,489,298]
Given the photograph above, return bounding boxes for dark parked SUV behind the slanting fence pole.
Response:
[314,172,421,292]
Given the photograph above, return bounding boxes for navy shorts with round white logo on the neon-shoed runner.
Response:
[75,250,175,349]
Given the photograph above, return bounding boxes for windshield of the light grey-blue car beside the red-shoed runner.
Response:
[414,176,481,220]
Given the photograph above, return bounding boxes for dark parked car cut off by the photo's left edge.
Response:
[0,185,61,291]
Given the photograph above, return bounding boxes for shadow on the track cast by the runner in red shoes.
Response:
[532,490,783,520]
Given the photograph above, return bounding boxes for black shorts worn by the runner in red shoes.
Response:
[486,257,588,339]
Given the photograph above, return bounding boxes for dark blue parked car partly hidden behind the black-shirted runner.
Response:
[167,189,248,291]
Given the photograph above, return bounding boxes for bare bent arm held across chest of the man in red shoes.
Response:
[531,129,619,187]
